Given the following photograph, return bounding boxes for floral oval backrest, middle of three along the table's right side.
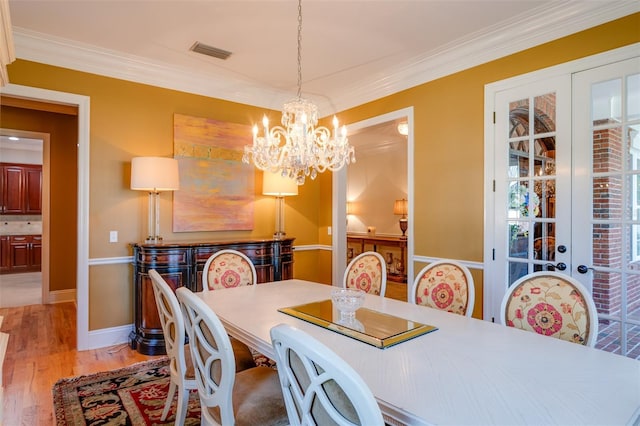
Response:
[409,260,476,317]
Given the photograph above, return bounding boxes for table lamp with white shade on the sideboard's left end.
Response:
[131,157,180,243]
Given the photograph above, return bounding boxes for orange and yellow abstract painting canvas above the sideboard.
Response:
[173,114,254,232]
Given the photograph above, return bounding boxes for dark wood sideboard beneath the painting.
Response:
[129,238,294,355]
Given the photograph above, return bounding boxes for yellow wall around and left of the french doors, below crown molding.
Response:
[332,13,640,318]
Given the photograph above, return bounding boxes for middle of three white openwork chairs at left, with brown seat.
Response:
[176,287,288,426]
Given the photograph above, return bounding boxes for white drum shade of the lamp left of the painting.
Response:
[131,157,180,191]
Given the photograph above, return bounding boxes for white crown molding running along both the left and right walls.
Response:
[13,0,640,116]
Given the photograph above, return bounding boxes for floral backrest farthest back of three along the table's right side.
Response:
[342,251,387,296]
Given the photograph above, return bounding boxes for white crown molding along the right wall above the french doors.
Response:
[331,1,640,110]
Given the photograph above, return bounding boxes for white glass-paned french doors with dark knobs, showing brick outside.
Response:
[485,53,640,358]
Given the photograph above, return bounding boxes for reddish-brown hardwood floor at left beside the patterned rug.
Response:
[0,302,158,426]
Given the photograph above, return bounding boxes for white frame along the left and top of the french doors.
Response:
[483,43,640,321]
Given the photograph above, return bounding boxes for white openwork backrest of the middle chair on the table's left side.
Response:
[176,287,236,425]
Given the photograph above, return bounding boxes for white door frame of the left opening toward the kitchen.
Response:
[1,84,91,351]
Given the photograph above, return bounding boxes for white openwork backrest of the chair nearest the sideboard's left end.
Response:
[149,269,190,380]
